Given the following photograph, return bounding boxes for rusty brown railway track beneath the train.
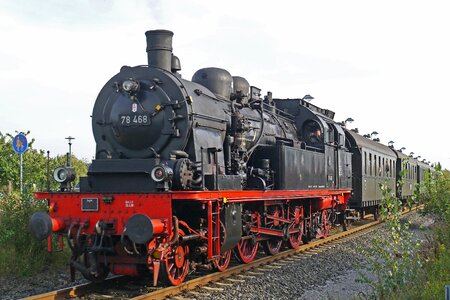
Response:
[25,207,420,300]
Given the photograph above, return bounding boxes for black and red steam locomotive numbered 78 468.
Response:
[31,30,430,285]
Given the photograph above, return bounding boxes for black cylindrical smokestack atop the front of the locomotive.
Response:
[145,30,173,72]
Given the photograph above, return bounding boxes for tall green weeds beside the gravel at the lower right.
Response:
[358,161,450,299]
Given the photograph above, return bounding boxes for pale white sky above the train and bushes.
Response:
[0,0,450,169]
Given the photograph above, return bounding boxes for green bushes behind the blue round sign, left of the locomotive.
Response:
[0,132,87,276]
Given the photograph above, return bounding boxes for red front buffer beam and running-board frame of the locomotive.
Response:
[35,189,351,259]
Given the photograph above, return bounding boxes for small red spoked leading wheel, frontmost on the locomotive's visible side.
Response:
[160,229,189,285]
